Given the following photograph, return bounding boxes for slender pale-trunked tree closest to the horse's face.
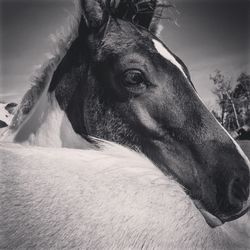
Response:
[210,70,240,129]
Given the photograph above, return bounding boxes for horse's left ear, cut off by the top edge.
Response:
[80,0,109,31]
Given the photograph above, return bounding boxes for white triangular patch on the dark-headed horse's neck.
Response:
[1,93,93,149]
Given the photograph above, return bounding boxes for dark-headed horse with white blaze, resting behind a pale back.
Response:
[2,0,250,243]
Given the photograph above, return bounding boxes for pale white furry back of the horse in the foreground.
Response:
[0,142,250,250]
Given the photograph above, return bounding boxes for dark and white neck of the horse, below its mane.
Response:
[3,36,89,148]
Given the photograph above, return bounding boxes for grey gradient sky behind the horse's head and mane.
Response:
[0,0,250,106]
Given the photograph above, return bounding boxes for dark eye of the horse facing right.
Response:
[123,70,145,87]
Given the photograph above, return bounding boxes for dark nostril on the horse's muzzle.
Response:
[228,179,249,209]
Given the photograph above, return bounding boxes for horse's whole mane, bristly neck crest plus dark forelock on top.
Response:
[9,0,173,130]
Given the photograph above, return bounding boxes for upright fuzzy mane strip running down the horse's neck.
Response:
[9,0,82,130]
